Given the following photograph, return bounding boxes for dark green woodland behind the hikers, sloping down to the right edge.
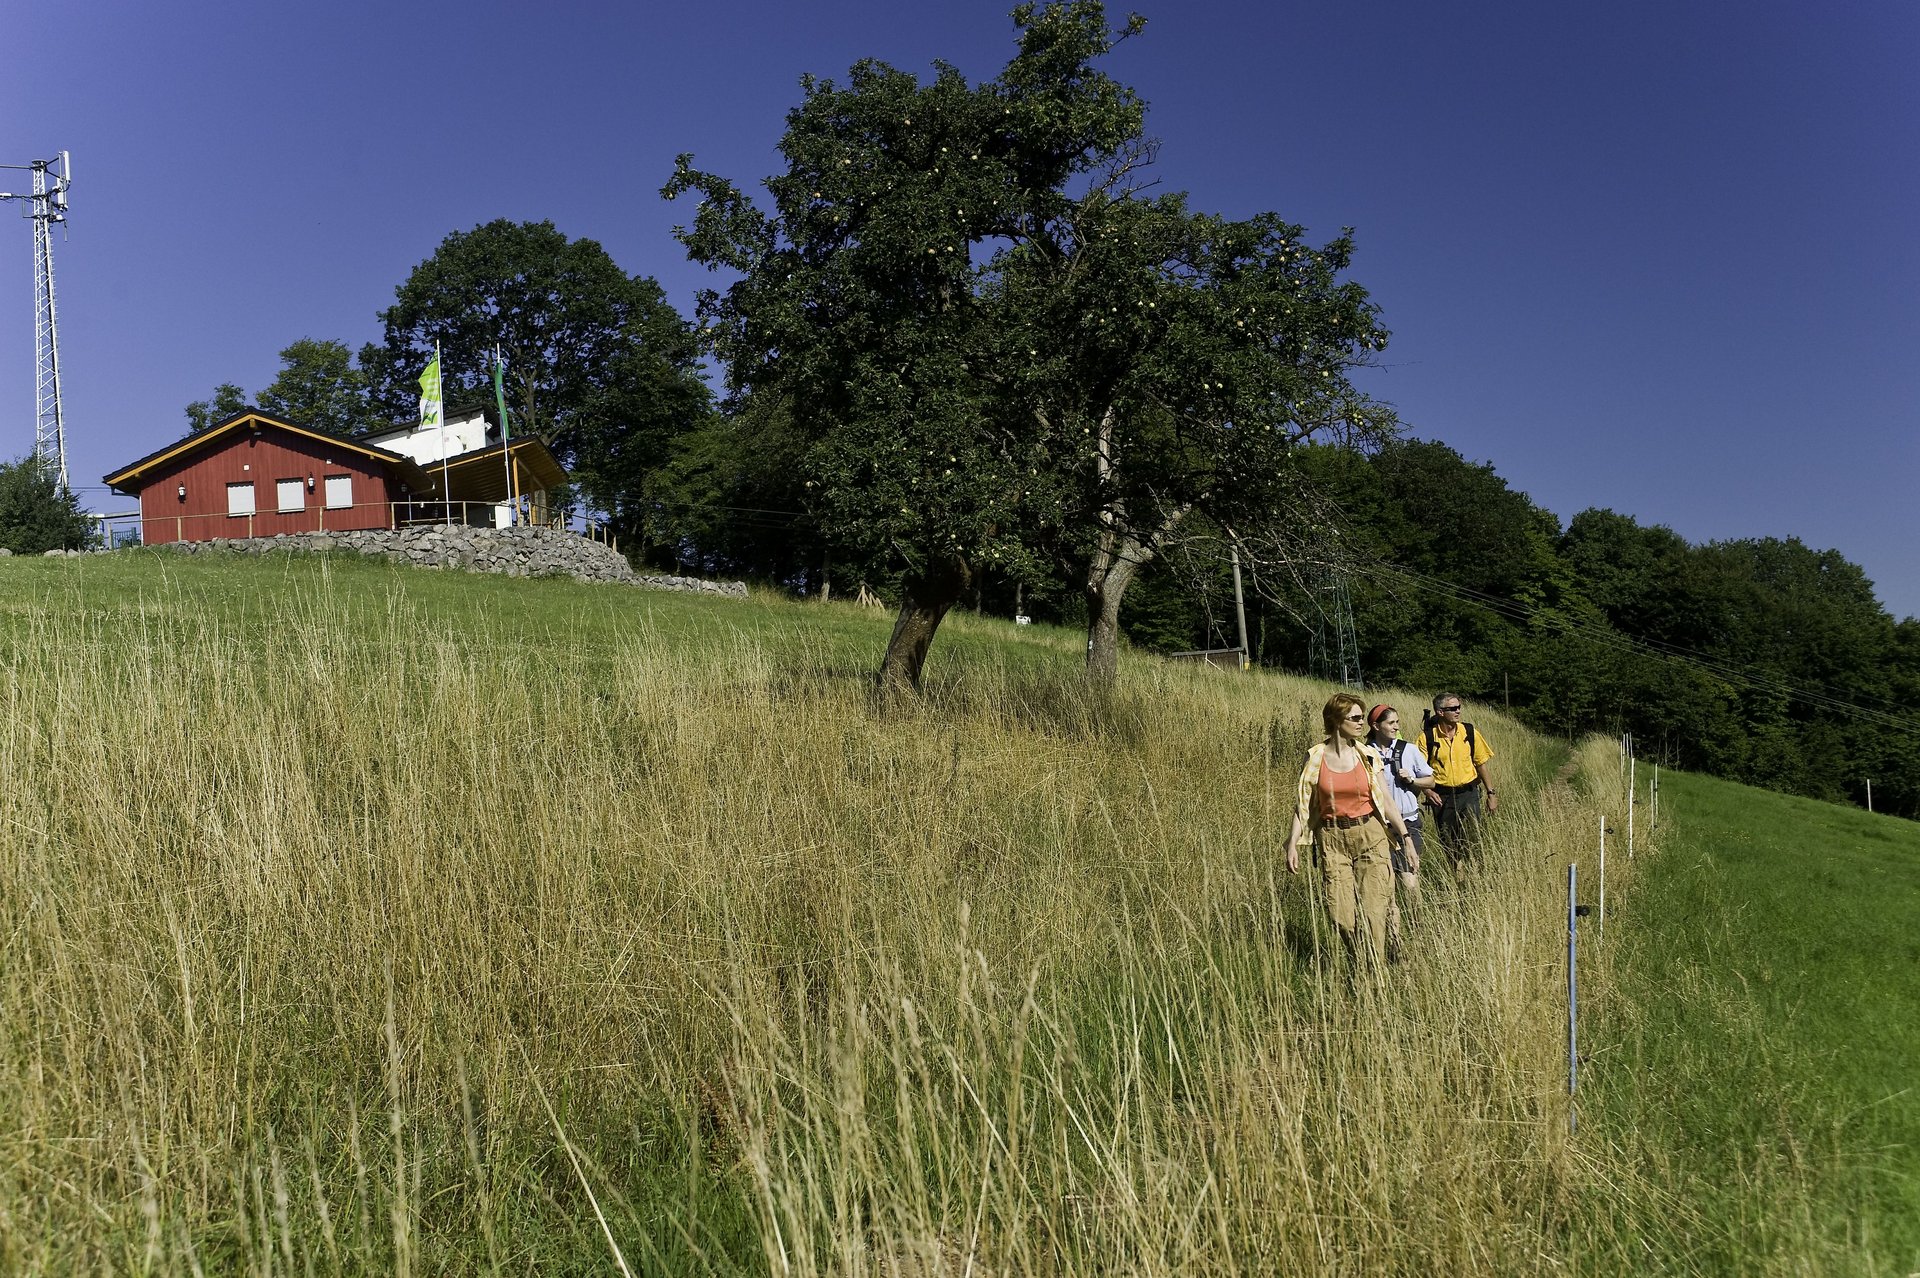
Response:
[1121,439,1920,816]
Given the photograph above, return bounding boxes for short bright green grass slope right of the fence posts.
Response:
[1590,759,1920,1274]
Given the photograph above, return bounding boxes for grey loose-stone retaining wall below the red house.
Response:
[30,524,747,599]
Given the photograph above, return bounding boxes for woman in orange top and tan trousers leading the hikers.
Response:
[1286,693,1407,961]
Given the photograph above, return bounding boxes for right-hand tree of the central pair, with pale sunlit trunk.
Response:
[995,189,1398,683]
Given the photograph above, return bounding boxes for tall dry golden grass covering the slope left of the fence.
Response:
[0,562,1620,1274]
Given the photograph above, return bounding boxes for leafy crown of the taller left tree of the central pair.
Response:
[666,2,1140,594]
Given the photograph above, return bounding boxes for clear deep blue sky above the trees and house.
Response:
[0,0,1920,616]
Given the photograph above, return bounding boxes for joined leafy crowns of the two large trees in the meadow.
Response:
[664,0,1394,672]
